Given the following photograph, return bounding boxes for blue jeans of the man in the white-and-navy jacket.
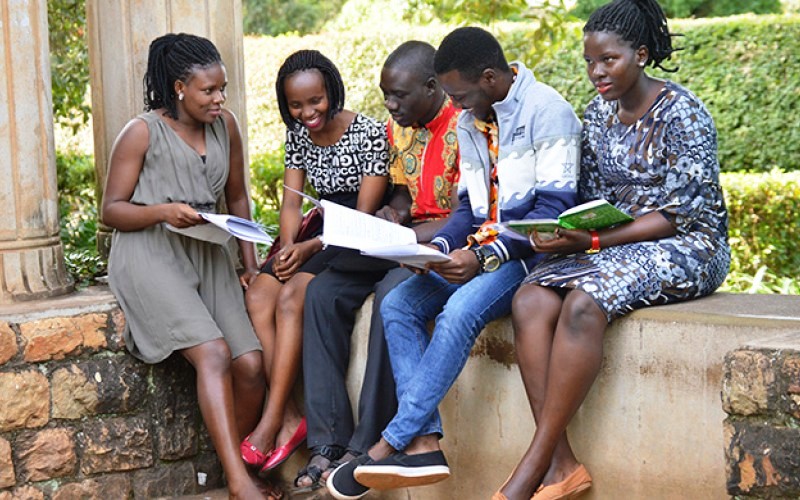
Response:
[381,260,527,450]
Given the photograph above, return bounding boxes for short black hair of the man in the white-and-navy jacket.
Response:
[433,26,510,82]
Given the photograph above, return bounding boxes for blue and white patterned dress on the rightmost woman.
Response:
[525,81,730,321]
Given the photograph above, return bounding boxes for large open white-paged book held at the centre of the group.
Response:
[321,200,450,268]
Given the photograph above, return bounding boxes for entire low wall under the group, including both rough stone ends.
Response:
[0,288,800,500]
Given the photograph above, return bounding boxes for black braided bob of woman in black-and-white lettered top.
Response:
[275,50,344,128]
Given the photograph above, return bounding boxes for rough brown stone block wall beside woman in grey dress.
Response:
[0,289,222,500]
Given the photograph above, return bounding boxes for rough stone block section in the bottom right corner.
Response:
[722,335,800,498]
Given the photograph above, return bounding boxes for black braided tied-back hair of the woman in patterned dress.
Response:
[583,0,681,72]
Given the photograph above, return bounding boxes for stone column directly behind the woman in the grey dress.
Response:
[86,0,247,255]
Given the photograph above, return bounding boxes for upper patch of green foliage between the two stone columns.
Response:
[47,0,91,132]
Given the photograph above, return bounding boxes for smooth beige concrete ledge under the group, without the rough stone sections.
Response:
[328,293,800,500]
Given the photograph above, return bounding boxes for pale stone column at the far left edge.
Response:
[0,0,73,304]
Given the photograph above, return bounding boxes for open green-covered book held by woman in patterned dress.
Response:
[498,200,633,239]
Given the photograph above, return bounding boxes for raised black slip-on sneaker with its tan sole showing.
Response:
[354,451,450,490]
